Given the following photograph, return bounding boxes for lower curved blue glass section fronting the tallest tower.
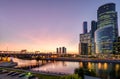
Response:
[95,25,114,53]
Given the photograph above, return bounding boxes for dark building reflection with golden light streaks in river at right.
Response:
[79,62,120,79]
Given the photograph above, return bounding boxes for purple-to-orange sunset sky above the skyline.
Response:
[0,0,120,53]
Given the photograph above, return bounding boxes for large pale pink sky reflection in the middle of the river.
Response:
[32,61,79,74]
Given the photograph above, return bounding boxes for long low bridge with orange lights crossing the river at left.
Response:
[0,51,60,59]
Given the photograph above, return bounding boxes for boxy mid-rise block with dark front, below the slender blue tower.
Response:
[79,33,91,55]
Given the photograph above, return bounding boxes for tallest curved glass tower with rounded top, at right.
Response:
[95,3,118,54]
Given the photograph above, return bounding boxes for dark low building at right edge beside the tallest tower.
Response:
[113,37,120,54]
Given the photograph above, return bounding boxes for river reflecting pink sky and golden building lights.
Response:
[13,58,120,79]
